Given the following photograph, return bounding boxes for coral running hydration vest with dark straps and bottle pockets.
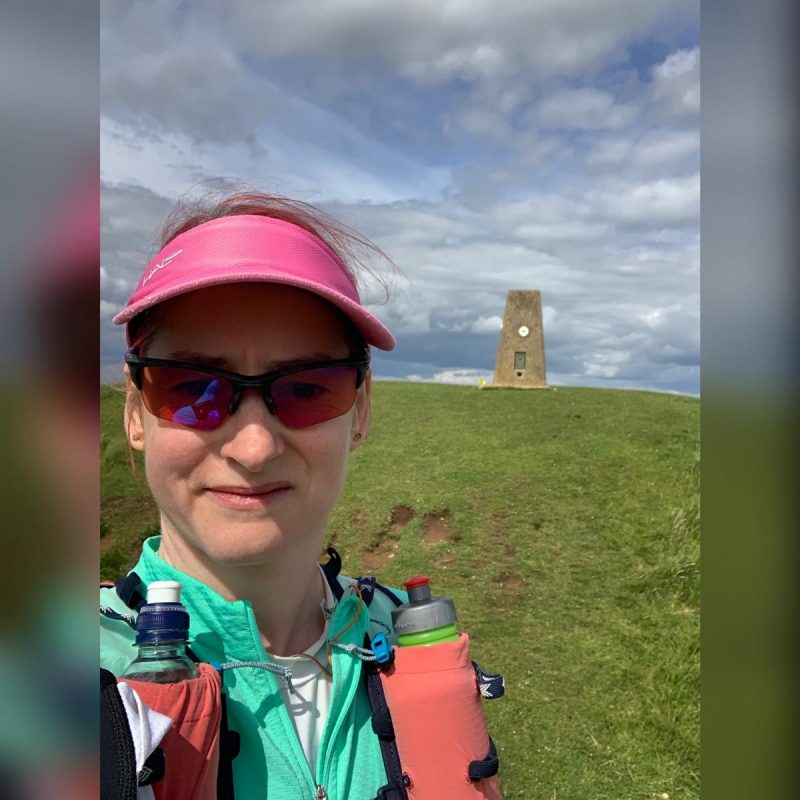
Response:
[101,548,504,800]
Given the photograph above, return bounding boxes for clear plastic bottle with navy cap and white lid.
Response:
[122,581,200,683]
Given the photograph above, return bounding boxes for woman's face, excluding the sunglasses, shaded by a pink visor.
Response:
[127,284,369,579]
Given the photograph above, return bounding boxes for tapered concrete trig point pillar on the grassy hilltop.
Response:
[492,289,547,389]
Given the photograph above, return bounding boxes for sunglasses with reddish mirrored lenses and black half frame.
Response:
[125,349,369,431]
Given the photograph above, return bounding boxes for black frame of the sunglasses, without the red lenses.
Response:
[125,348,369,427]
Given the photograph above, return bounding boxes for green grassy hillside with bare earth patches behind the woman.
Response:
[101,382,700,800]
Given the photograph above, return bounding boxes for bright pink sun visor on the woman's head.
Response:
[114,214,395,350]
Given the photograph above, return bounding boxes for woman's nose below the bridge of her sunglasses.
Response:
[220,390,284,472]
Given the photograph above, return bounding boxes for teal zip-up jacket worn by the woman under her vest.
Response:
[100,536,406,800]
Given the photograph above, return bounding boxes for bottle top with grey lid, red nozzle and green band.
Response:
[392,575,458,647]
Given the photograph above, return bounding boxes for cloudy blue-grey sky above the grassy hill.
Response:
[100,0,700,394]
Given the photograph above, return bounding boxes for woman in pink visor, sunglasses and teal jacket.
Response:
[101,194,410,800]
